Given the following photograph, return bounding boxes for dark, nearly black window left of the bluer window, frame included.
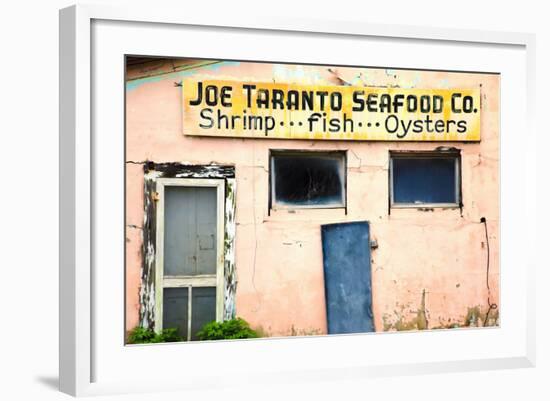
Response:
[271,152,345,208]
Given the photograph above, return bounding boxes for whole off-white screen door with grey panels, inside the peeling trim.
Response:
[156,179,223,340]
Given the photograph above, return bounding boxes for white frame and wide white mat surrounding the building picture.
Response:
[59,5,535,396]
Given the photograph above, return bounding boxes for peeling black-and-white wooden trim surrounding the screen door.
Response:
[139,161,237,329]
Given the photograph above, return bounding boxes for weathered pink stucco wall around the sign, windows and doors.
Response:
[126,58,500,335]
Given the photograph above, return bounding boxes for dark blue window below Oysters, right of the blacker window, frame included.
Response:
[390,152,460,206]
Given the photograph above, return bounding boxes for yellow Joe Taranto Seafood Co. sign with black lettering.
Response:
[183,80,481,141]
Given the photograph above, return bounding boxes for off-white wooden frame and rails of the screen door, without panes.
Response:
[155,178,225,341]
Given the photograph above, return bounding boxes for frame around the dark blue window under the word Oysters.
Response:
[388,148,462,209]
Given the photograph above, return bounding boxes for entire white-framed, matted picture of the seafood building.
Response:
[60,6,535,395]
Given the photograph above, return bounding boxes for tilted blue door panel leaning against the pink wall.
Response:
[321,221,374,334]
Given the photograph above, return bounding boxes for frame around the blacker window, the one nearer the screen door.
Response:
[268,149,348,210]
